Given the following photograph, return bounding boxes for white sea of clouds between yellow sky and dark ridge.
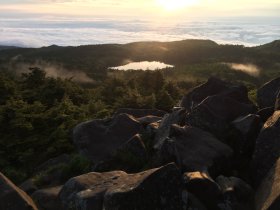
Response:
[0,18,280,47]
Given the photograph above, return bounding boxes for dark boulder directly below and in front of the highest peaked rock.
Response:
[186,95,256,139]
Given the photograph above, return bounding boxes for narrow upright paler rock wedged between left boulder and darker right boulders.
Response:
[154,108,186,149]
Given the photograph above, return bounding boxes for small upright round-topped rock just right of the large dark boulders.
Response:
[232,114,261,158]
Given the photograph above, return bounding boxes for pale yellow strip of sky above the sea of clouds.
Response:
[0,0,280,18]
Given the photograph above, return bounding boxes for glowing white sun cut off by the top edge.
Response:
[156,0,198,11]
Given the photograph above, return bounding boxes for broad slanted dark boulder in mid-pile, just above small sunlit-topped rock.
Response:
[157,125,233,176]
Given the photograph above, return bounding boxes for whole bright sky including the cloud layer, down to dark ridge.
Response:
[0,0,280,47]
